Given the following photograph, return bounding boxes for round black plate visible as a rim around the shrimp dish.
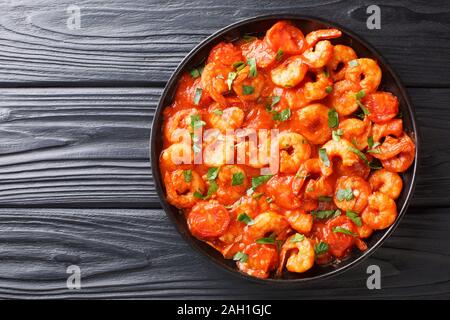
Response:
[150,15,419,283]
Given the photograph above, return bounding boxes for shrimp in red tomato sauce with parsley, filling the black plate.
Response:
[159,20,416,279]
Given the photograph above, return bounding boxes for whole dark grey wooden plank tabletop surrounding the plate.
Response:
[0,0,450,299]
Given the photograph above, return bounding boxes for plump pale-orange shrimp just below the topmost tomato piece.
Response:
[270,56,308,88]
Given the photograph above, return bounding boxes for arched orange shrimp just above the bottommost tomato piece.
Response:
[243,211,289,243]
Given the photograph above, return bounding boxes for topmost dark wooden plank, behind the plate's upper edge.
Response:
[0,0,450,87]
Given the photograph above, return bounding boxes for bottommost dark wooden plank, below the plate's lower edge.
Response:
[0,208,450,299]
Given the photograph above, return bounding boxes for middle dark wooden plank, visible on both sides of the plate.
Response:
[0,88,450,208]
